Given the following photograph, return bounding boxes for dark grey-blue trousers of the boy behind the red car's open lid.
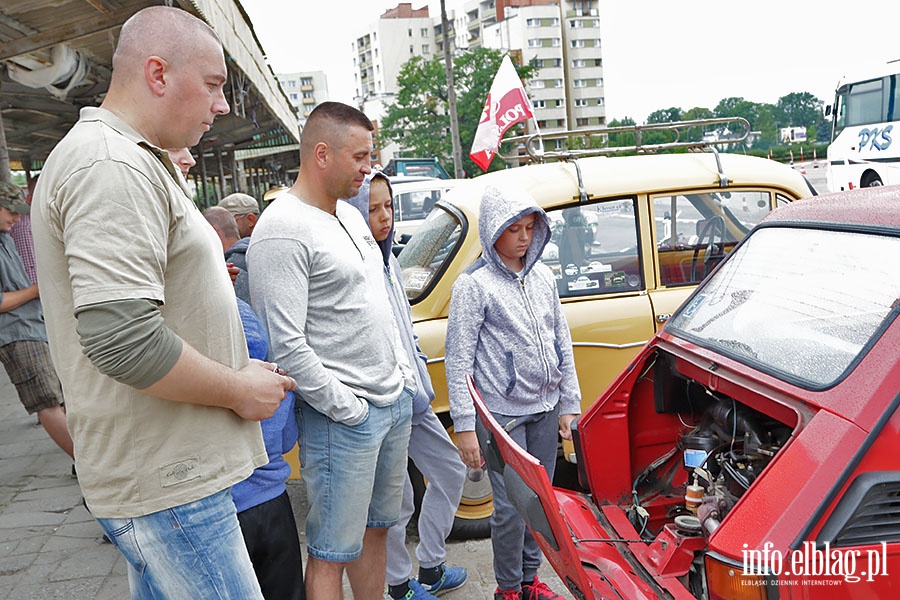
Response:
[475,404,559,590]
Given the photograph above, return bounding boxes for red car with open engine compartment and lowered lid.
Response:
[470,187,900,600]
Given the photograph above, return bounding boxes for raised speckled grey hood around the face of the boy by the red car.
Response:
[478,186,550,276]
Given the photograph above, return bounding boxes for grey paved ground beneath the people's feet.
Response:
[0,370,571,600]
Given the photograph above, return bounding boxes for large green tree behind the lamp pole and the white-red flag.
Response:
[379,48,536,174]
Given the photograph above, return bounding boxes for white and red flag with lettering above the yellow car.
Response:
[469,54,534,171]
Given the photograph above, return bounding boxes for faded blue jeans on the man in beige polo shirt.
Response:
[97,488,263,600]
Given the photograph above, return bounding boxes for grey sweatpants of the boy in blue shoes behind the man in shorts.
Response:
[386,407,466,585]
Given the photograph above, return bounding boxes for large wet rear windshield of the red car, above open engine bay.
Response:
[666,227,900,389]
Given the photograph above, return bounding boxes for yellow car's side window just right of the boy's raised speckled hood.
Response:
[541,199,644,298]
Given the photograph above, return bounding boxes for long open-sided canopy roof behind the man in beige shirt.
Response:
[0,0,300,204]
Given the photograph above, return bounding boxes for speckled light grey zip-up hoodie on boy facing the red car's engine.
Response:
[446,187,581,431]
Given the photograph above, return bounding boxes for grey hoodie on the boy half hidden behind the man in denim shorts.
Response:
[347,171,434,414]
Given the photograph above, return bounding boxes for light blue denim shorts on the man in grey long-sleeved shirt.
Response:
[296,388,414,562]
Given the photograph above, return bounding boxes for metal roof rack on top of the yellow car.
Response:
[498,117,750,162]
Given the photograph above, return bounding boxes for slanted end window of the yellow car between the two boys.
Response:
[397,207,462,302]
